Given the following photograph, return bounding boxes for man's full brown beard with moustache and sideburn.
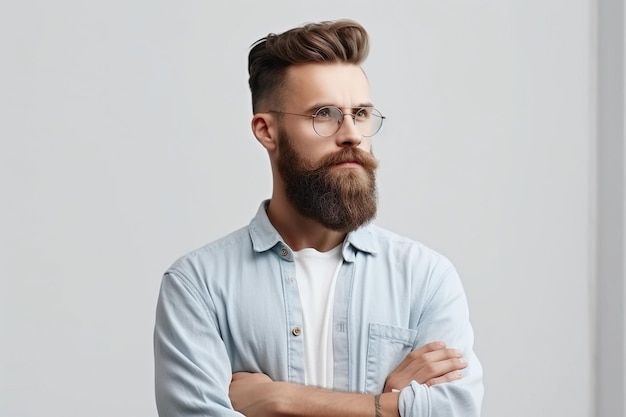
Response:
[278,129,378,233]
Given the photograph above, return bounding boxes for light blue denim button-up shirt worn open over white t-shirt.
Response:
[154,201,483,417]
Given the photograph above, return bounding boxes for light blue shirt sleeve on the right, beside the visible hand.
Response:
[398,263,484,417]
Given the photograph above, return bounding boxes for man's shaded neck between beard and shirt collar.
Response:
[267,193,347,252]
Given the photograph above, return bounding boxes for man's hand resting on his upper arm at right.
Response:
[383,342,467,392]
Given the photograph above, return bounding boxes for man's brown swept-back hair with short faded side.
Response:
[248,19,369,113]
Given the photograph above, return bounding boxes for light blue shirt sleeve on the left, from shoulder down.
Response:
[154,273,242,417]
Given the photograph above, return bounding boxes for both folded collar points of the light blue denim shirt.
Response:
[249,200,377,262]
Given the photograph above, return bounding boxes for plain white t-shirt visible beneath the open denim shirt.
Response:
[294,245,343,388]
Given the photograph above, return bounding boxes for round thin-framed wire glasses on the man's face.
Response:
[268,106,385,138]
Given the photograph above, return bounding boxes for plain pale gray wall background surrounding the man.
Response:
[0,0,625,417]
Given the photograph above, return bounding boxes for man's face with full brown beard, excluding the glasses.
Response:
[277,64,378,232]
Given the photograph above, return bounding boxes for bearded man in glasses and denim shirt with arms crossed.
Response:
[155,20,483,417]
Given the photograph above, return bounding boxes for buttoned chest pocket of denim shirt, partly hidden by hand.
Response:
[365,323,417,394]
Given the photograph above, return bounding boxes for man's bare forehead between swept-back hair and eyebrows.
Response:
[285,63,371,111]
